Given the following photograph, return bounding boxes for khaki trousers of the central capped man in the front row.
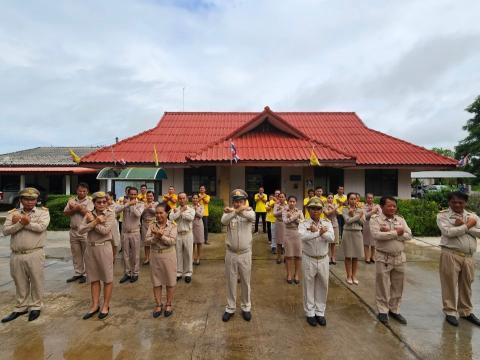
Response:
[225,250,252,314]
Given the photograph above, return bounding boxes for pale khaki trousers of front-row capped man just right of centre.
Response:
[302,254,329,317]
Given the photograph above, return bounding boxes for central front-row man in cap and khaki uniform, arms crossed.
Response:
[221,189,255,322]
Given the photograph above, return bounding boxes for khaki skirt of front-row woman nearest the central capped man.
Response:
[150,247,177,287]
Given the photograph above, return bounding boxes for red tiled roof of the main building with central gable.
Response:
[82,108,456,167]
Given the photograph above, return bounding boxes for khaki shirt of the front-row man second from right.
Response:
[370,214,412,254]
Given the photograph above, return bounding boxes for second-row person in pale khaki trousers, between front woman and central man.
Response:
[168,192,195,283]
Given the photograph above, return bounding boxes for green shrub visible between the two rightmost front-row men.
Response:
[398,199,440,236]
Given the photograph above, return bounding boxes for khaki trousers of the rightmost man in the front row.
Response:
[440,250,475,316]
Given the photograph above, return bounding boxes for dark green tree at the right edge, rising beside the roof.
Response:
[455,96,480,183]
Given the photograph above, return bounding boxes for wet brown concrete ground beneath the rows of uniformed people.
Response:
[0,232,480,359]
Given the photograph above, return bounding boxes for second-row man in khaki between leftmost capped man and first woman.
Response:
[63,183,93,283]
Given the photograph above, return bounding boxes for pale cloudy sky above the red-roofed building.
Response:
[0,0,480,153]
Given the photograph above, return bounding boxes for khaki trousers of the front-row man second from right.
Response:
[375,251,406,314]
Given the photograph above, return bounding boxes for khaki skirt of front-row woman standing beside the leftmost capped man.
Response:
[84,241,113,284]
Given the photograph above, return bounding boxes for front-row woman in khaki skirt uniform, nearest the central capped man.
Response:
[146,204,177,318]
